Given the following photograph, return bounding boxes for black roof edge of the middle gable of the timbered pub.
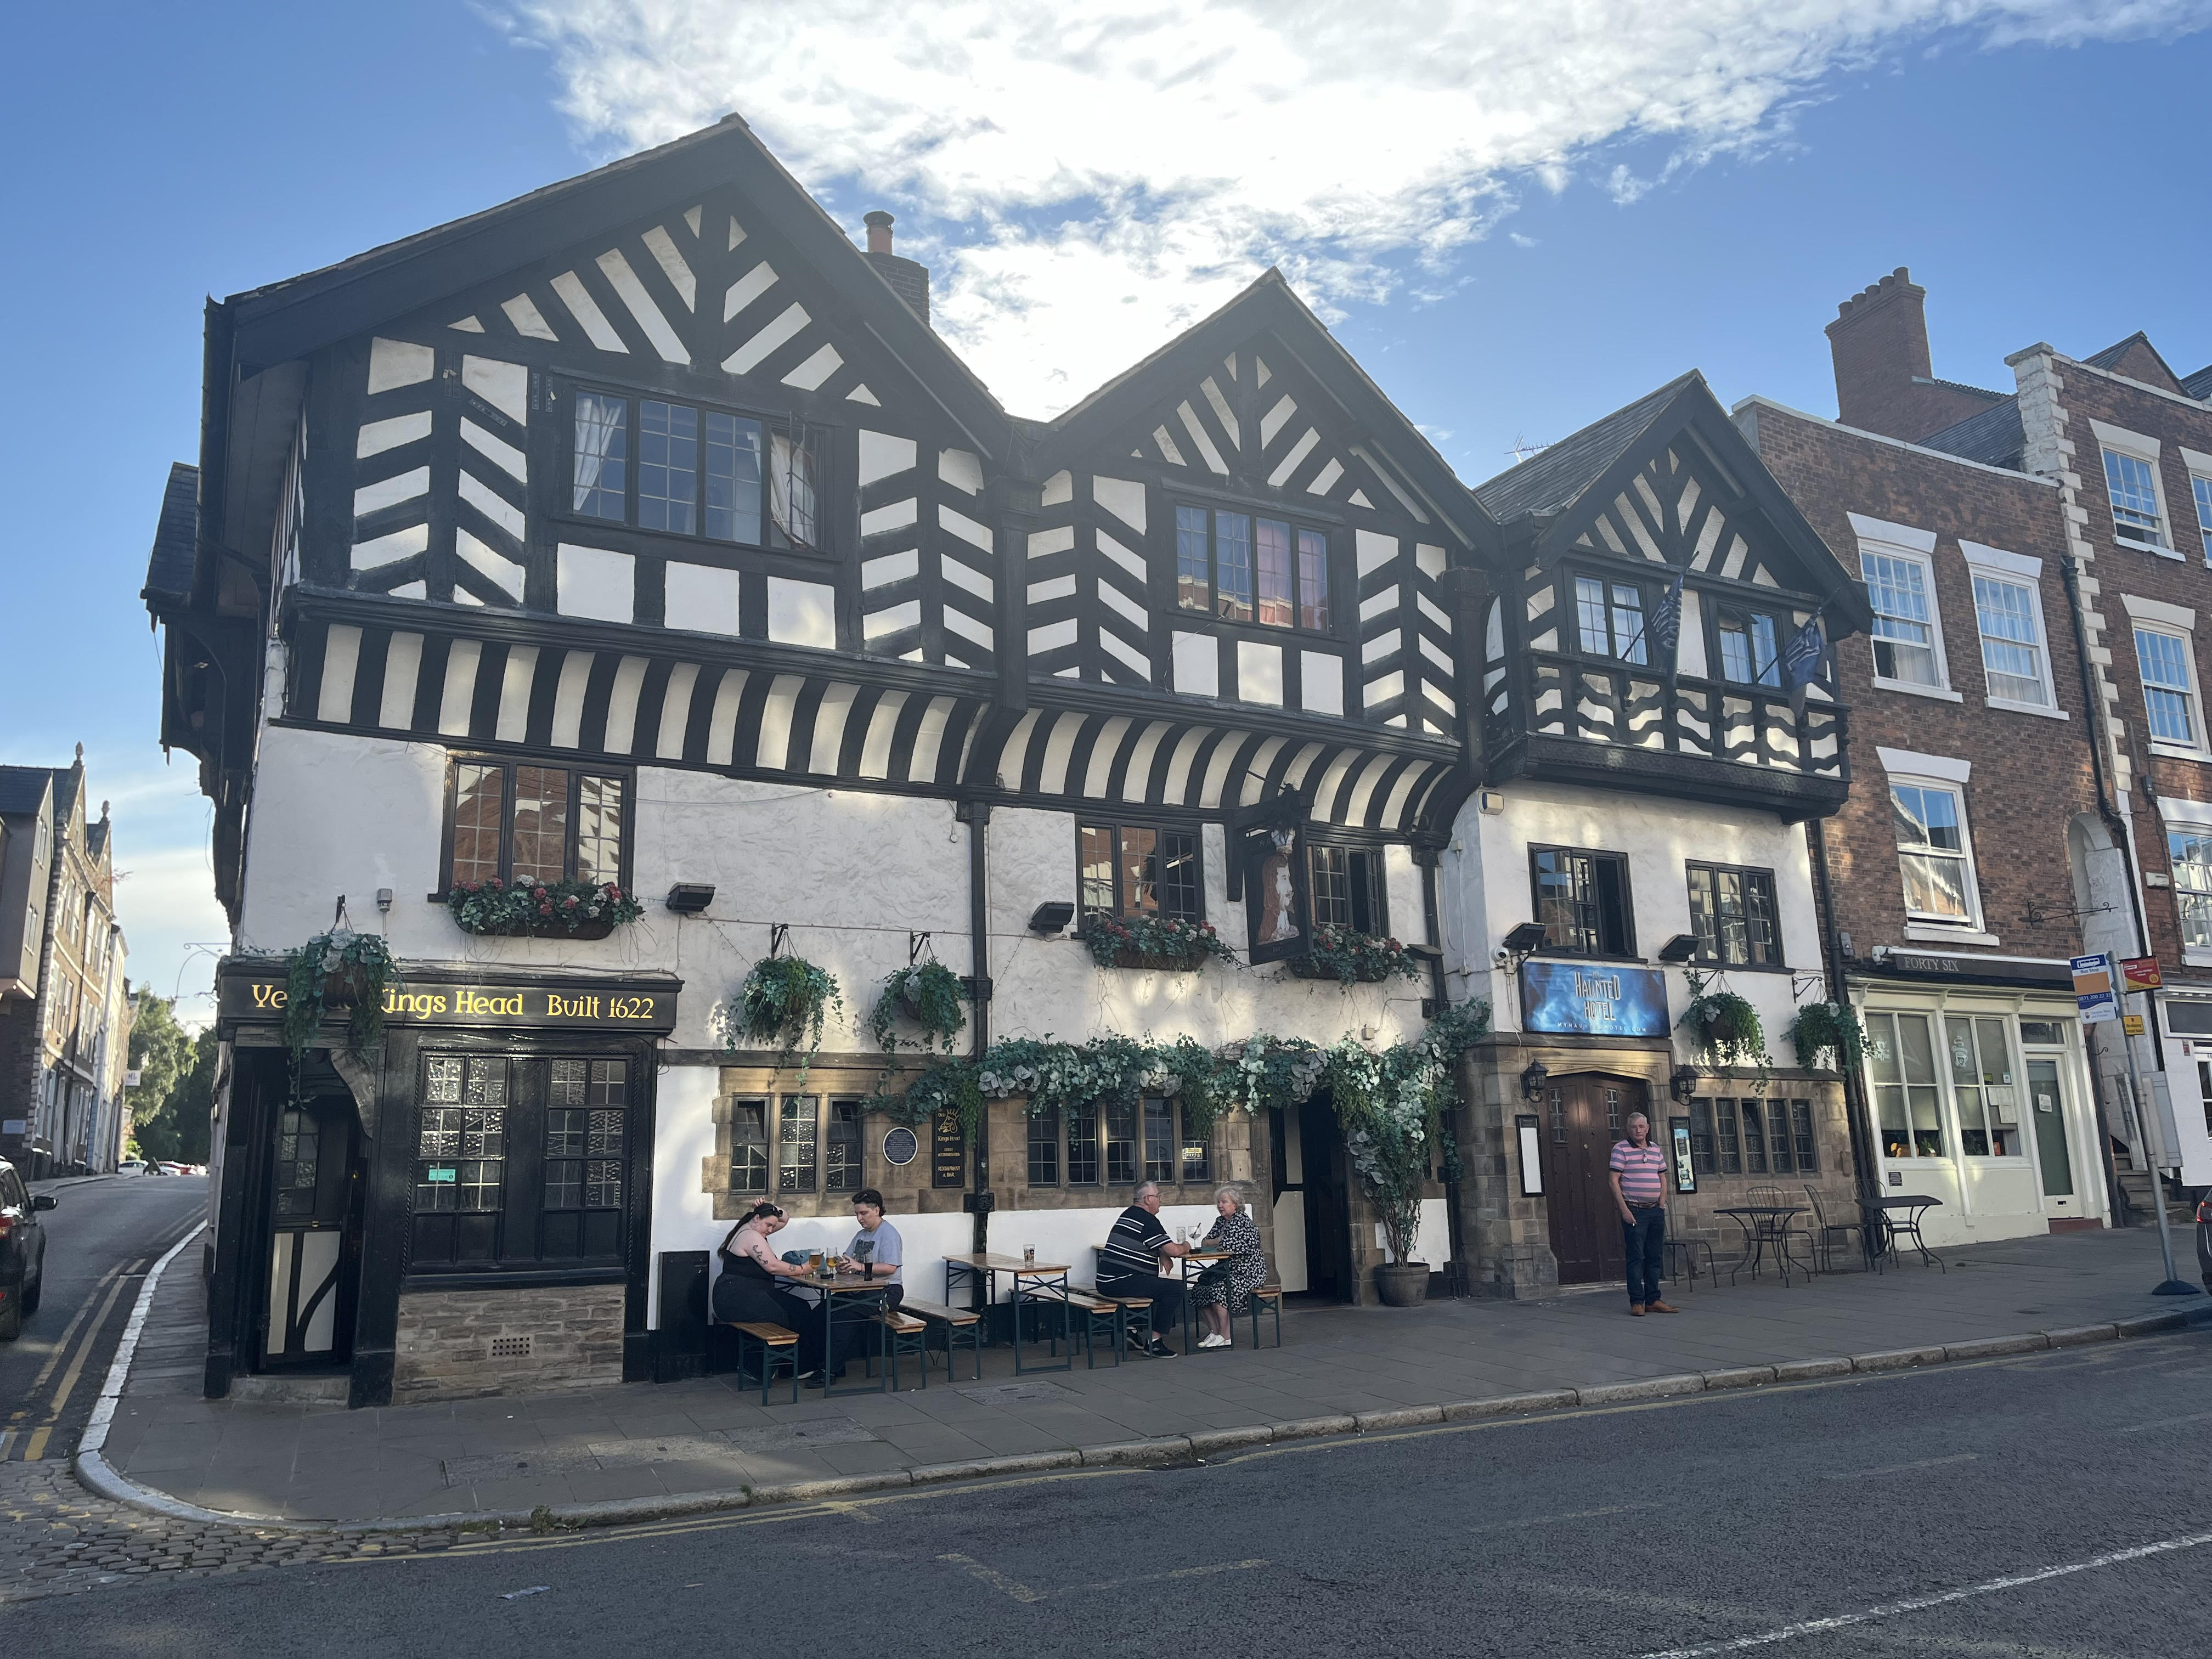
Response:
[1037,266,1484,542]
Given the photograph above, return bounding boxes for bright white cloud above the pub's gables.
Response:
[513,0,2212,414]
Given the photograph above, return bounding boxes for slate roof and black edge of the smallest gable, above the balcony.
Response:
[1475,369,1871,635]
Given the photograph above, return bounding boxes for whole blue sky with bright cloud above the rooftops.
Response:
[0,0,2212,1013]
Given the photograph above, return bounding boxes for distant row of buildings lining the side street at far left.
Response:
[0,743,131,1179]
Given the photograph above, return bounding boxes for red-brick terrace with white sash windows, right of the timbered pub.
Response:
[1736,270,2212,1239]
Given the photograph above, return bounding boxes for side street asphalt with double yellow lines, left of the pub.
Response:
[0,1175,208,1462]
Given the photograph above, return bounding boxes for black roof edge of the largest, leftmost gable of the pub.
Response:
[221,115,1009,455]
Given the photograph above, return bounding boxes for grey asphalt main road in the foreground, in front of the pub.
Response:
[9,1331,2212,1659]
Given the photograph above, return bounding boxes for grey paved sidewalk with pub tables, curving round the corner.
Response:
[91,1230,2212,1522]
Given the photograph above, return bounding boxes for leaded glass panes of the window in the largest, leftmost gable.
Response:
[568,392,821,549]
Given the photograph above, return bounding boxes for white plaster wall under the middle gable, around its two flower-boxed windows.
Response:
[991,808,1427,1044]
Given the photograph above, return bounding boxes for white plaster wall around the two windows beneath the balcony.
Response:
[1442,783,1822,1066]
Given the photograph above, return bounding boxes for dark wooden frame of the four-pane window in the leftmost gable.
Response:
[550,374,847,568]
